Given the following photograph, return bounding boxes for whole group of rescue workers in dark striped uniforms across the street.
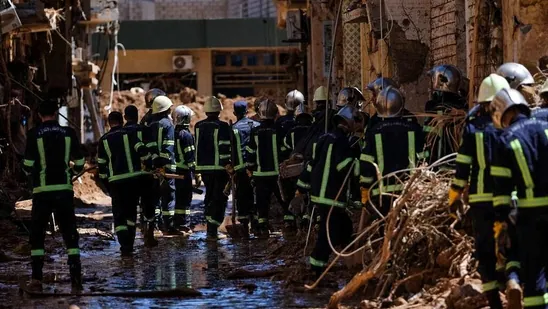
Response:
[24,57,548,308]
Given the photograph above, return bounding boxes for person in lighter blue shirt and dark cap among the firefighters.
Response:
[232,101,260,237]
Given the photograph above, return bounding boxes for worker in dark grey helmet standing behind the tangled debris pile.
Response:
[423,64,467,162]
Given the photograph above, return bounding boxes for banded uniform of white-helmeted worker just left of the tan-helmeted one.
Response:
[175,126,196,227]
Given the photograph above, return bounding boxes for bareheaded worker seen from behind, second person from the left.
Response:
[97,112,150,257]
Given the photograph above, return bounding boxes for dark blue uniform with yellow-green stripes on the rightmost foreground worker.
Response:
[491,115,548,308]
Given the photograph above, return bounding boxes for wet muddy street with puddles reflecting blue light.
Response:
[0,190,352,308]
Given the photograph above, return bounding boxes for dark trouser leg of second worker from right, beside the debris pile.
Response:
[470,203,502,309]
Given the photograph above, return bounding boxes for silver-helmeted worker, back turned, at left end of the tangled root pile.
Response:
[360,86,424,216]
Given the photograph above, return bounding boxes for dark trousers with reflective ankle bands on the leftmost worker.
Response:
[30,191,81,280]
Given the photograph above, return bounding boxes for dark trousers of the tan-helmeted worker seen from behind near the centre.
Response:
[202,170,229,235]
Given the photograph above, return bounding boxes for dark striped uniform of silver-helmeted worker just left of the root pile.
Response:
[360,117,425,215]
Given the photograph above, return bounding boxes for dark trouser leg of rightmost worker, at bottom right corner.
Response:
[516,206,548,308]
